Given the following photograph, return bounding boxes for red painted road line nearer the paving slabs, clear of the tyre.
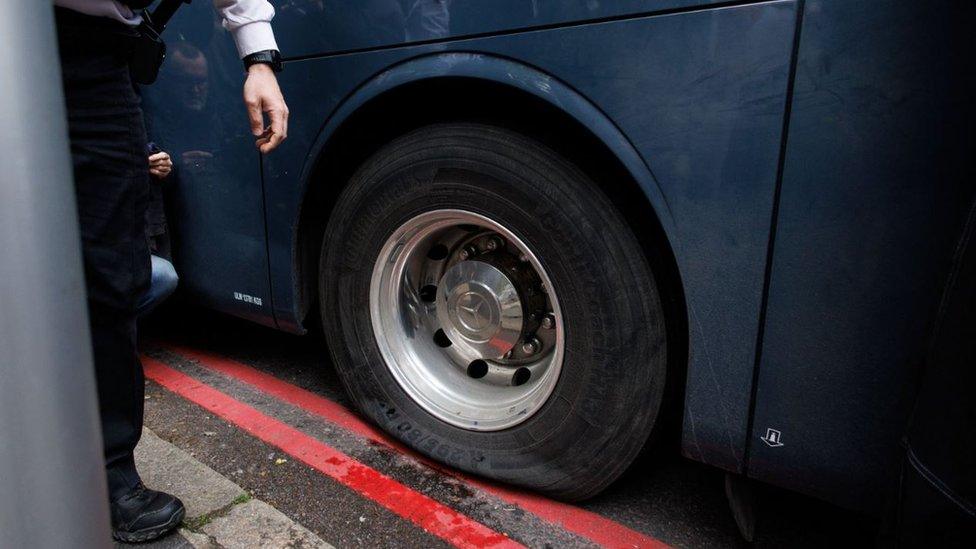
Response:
[143,357,523,549]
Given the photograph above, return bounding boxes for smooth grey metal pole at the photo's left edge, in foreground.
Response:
[0,0,111,548]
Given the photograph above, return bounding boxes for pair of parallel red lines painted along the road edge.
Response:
[143,347,667,548]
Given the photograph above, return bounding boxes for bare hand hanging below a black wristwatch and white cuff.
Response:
[244,63,288,153]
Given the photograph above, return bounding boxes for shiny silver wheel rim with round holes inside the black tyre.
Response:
[369,210,565,431]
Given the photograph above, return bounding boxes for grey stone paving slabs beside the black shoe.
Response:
[116,429,332,549]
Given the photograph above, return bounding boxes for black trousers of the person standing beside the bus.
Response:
[57,9,150,499]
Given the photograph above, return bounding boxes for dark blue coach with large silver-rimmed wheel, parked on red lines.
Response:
[144,0,972,512]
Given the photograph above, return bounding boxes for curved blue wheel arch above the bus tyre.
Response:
[294,53,688,425]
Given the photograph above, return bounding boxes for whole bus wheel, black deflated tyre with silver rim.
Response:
[319,124,666,499]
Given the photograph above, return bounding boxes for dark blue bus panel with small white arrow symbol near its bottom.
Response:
[748,0,973,510]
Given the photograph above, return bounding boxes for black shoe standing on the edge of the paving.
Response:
[112,483,186,543]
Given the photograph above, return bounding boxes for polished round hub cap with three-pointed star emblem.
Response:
[437,261,522,358]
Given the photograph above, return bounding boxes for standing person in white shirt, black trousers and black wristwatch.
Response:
[54,0,288,542]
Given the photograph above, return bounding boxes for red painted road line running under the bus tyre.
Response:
[167,345,669,548]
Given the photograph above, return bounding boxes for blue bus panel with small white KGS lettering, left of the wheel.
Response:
[142,7,276,326]
